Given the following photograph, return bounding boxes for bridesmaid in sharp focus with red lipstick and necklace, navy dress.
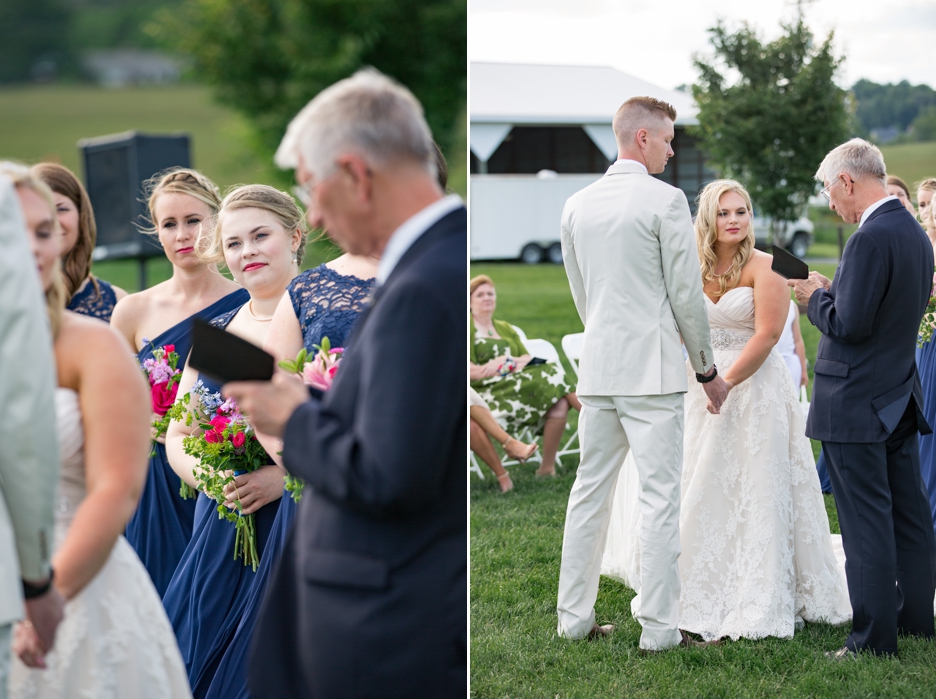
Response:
[163,185,305,697]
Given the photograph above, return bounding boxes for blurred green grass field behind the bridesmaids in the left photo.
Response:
[0,84,468,292]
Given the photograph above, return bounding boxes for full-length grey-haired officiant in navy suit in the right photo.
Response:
[790,138,936,659]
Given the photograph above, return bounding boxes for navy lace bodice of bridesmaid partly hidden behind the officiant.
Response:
[287,264,374,352]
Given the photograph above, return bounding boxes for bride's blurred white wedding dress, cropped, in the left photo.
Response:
[9,388,192,699]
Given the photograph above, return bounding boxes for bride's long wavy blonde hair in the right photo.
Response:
[695,180,754,296]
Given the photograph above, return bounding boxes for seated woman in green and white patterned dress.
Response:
[469,274,582,476]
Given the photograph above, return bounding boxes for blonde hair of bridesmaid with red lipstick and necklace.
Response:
[196,184,308,265]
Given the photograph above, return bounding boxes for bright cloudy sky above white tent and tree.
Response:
[476,0,936,88]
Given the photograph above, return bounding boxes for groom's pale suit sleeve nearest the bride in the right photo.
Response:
[660,190,714,374]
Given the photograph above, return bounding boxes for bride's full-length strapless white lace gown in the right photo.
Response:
[601,287,851,640]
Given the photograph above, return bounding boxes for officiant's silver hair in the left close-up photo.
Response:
[275,68,436,180]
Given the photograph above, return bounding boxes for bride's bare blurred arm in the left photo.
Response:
[52,321,150,599]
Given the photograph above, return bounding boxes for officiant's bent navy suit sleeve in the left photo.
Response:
[283,280,467,516]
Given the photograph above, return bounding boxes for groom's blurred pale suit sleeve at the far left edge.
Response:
[0,179,59,580]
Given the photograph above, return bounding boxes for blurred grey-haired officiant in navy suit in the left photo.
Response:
[224,70,468,699]
